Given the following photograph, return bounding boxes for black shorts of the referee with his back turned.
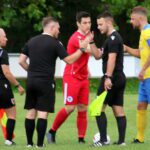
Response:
[24,78,55,113]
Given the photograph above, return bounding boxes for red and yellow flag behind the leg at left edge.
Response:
[0,109,14,139]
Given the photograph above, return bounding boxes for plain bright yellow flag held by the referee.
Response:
[89,91,107,117]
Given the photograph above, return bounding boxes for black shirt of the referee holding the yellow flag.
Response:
[102,31,123,74]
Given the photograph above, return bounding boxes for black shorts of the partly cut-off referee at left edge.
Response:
[0,80,15,109]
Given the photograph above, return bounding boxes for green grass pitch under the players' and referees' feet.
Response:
[0,92,150,150]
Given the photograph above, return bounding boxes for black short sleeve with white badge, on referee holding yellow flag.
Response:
[108,35,120,53]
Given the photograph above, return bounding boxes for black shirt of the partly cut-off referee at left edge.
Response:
[0,48,9,80]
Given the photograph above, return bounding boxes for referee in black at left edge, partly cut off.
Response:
[0,28,24,146]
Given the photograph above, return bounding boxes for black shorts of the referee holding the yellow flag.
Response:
[97,73,126,106]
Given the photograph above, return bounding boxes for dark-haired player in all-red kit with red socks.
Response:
[47,11,101,143]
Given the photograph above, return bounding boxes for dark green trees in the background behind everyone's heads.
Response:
[0,0,150,53]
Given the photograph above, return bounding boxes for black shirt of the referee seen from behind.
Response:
[22,34,68,80]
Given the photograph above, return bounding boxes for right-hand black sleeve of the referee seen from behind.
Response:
[56,41,68,59]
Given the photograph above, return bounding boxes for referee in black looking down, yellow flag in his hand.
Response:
[94,12,126,146]
